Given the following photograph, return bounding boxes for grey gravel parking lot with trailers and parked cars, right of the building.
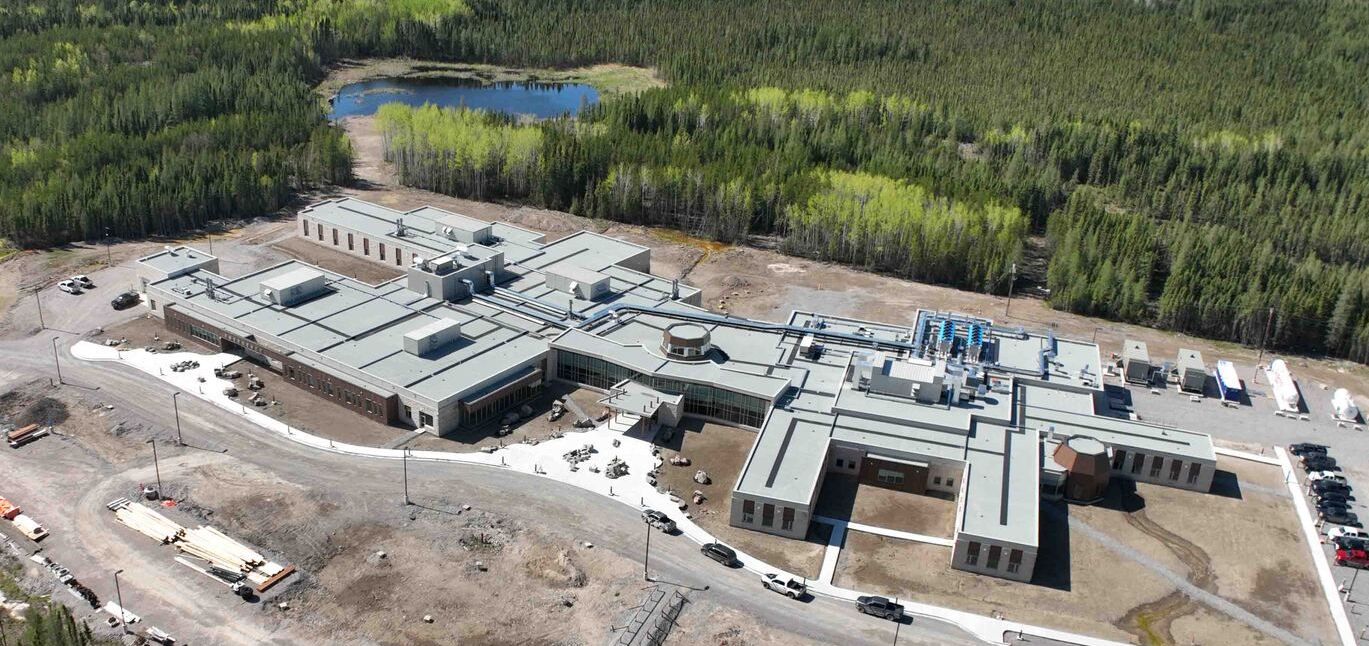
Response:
[1105,348,1369,635]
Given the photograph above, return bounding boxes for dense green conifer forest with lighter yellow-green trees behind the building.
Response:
[8,0,1369,361]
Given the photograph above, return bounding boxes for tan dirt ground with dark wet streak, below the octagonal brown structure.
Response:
[834,458,1335,645]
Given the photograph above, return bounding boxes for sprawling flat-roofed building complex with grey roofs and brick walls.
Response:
[138,198,1216,580]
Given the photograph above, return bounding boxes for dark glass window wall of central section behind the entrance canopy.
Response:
[556,350,769,428]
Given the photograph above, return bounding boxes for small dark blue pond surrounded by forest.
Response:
[329,78,598,119]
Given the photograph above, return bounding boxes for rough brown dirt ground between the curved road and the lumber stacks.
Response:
[169,463,641,643]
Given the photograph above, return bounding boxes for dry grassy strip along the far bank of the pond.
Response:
[318,59,665,100]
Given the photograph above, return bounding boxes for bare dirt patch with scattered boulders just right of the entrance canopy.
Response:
[657,420,831,579]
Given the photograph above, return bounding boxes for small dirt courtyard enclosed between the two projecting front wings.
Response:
[817,474,956,538]
